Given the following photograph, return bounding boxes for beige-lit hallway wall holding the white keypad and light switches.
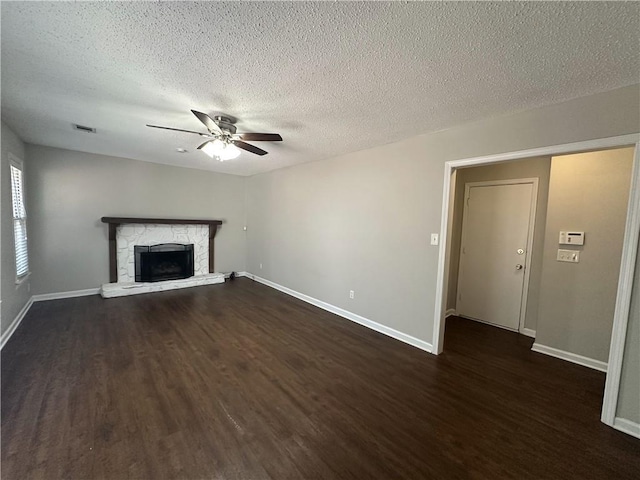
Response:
[536,148,634,362]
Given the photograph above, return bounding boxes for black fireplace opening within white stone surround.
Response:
[133,243,193,282]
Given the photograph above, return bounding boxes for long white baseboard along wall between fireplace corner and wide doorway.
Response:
[238,272,433,353]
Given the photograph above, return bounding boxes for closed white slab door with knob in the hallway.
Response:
[456,182,536,330]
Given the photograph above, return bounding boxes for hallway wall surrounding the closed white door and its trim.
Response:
[447,157,551,330]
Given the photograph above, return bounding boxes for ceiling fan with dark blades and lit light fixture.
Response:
[147,110,282,161]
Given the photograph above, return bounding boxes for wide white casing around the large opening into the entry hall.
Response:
[432,133,640,428]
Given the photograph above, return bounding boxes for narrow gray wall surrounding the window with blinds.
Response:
[0,122,32,334]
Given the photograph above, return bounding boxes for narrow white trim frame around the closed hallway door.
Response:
[456,177,539,334]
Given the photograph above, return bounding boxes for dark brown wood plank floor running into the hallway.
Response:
[2,279,640,480]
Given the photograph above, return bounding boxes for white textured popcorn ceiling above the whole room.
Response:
[1,1,640,175]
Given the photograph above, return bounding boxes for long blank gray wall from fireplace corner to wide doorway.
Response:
[247,139,442,341]
